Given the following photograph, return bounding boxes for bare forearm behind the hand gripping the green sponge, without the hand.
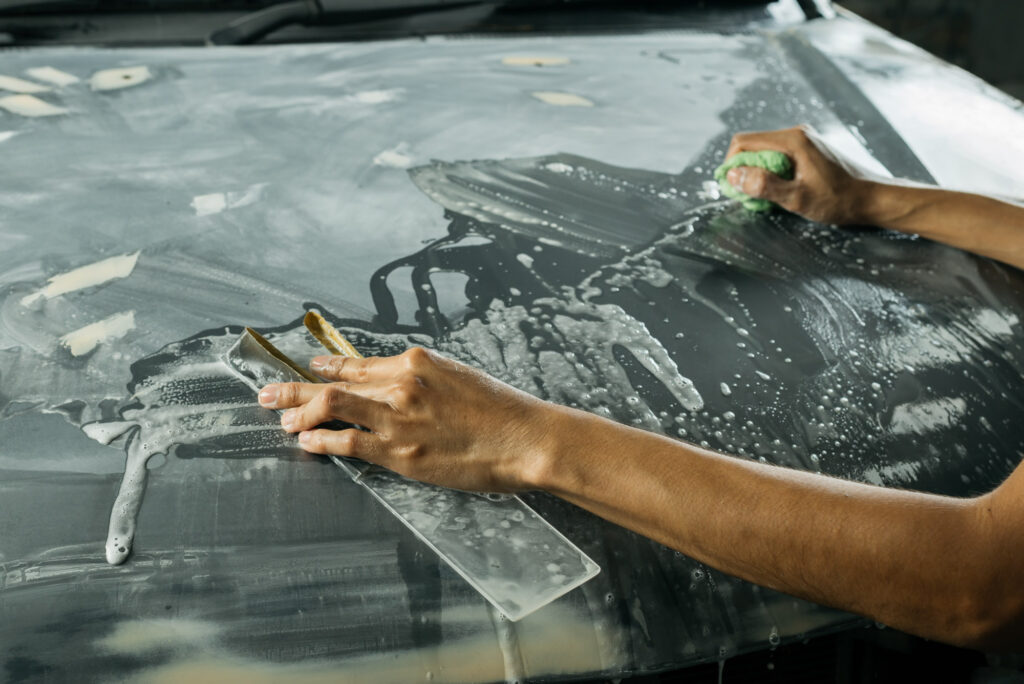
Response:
[856,181,1024,268]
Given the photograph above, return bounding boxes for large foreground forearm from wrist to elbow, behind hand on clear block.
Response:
[537,411,1003,643]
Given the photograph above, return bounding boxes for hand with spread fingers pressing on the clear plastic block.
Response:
[259,348,557,491]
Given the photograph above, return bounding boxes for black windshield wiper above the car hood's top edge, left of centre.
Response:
[206,0,489,45]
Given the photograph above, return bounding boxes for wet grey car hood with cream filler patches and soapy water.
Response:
[0,12,1024,682]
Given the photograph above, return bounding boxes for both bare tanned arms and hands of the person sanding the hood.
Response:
[259,127,1024,650]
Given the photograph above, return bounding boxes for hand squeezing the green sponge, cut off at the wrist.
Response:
[726,126,871,225]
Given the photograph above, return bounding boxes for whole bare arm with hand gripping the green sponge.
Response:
[728,127,1024,268]
